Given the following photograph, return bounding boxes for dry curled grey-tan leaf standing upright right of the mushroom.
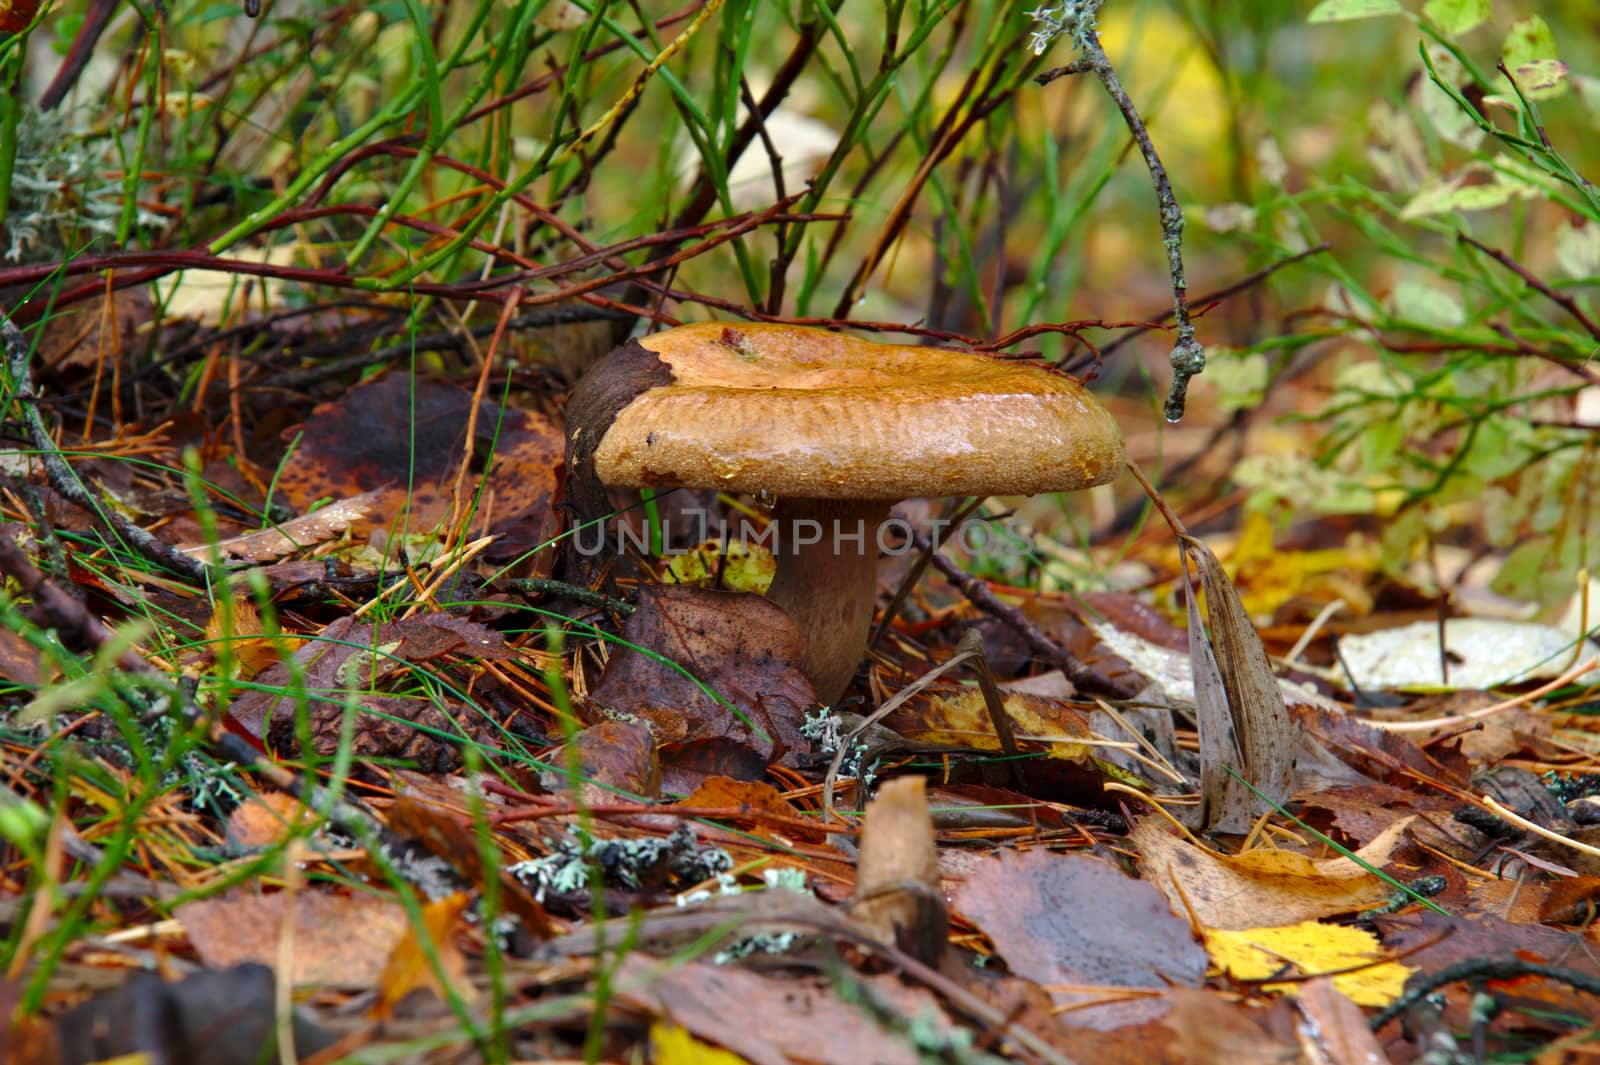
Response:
[1182,536,1294,832]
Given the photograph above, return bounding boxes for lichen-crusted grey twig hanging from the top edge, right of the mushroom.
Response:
[1029,0,1205,422]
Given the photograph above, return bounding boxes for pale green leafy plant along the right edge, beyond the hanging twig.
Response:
[1211,0,1600,600]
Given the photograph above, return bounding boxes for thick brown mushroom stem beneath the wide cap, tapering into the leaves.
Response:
[766,497,891,704]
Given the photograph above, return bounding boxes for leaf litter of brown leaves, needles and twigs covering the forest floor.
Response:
[9,236,1600,1062]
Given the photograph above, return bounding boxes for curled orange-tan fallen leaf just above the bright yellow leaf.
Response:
[1128,817,1411,931]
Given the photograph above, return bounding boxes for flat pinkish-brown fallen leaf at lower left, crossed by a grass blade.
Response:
[173,891,406,988]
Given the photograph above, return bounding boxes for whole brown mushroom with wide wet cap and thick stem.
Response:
[566,323,1126,704]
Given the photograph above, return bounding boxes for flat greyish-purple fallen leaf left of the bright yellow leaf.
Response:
[955,849,1208,1030]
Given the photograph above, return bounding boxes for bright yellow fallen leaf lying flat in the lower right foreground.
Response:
[1205,921,1411,1006]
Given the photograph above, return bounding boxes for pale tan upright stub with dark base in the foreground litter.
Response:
[850,777,950,967]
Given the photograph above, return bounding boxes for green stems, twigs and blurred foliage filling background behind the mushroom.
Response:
[0,0,1600,610]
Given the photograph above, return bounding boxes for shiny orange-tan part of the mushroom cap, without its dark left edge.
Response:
[590,323,1126,499]
